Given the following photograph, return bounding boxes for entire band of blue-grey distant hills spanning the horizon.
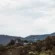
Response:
[0,33,55,44]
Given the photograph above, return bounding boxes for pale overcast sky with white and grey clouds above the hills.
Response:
[0,0,55,37]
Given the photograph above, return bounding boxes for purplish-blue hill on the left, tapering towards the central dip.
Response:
[0,35,23,44]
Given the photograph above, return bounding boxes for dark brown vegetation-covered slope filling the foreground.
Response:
[0,36,55,55]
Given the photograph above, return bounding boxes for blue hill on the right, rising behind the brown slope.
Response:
[25,33,55,42]
